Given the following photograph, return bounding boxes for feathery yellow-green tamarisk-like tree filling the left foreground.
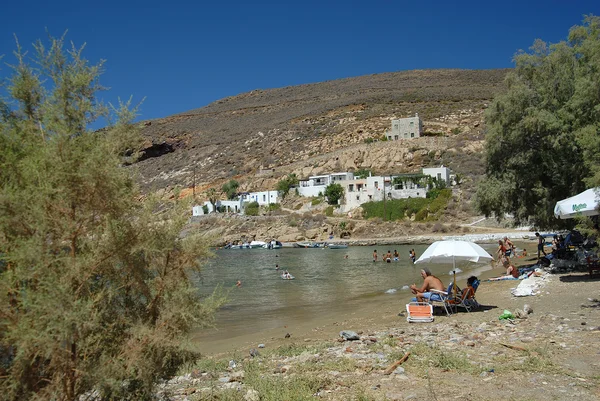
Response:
[0,38,221,400]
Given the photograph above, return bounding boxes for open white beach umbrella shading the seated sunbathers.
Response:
[415,240,494,294]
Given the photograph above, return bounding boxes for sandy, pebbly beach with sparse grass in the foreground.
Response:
[156,236,600,401]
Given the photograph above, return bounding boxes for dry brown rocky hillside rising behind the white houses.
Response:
[131,70,508,194]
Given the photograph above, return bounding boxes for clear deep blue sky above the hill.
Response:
[0,0,600,119]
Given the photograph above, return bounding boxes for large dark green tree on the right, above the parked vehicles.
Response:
[476,16,600,228]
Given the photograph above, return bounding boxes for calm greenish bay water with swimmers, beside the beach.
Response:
[190,245,494,341]
